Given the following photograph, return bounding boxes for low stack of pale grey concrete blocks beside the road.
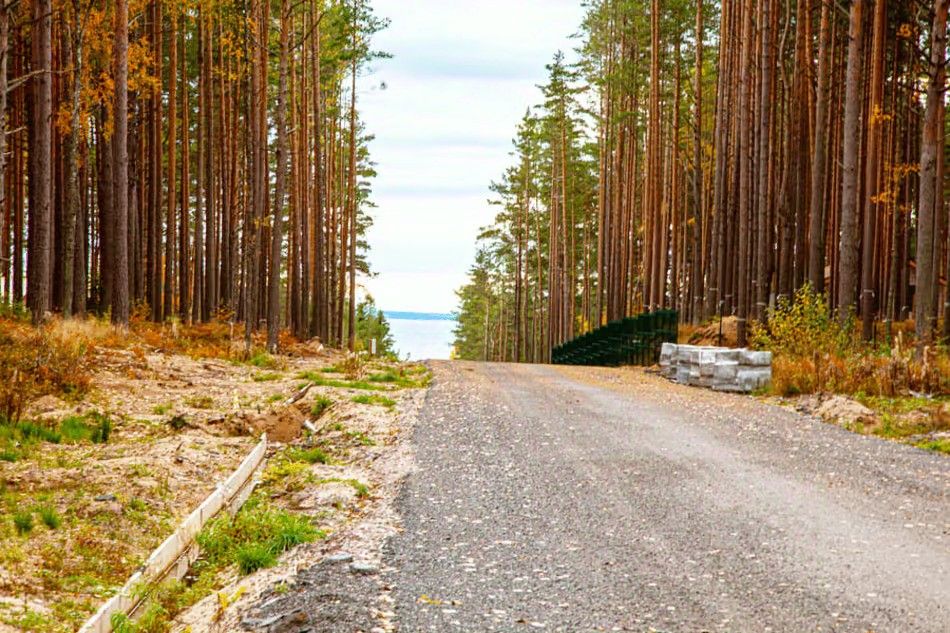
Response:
[660,343,772,393]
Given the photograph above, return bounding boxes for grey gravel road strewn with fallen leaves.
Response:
[381,362,950,633]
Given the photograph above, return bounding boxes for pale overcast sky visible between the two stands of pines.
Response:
[359,0,583,312]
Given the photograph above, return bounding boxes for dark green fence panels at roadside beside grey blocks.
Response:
[551,310,679,366]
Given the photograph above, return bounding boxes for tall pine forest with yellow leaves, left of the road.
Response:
[0,0,386,350]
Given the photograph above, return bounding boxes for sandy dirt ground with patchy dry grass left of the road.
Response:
[0,340,428,633]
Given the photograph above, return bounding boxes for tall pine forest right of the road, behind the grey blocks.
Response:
[456,0,950,362]
